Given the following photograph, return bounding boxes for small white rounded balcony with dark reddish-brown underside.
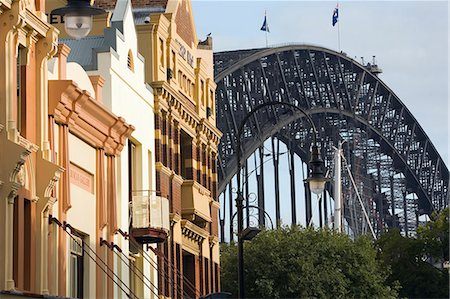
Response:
[130,190,170,244]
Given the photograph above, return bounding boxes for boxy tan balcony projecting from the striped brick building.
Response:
[181,180,211,228]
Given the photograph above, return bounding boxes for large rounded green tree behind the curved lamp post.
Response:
[221,226,397,298]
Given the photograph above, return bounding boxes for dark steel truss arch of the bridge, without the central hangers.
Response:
[214,45,449,237]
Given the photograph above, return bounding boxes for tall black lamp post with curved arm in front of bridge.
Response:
[235,101,327,298]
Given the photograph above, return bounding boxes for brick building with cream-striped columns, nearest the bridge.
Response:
[95,0,221,298]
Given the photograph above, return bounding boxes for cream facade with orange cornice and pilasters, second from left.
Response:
[46,44,134,298]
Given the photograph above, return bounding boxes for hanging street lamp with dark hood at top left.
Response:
[50,0,105,39]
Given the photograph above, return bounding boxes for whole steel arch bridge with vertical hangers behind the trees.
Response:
[214,45,449,241]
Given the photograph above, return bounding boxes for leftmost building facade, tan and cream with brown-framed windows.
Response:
[0,0,64,293]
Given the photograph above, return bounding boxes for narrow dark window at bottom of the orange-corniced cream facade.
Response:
[69,236,84,298]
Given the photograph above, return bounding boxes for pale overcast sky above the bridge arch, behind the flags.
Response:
[193,0,450,165]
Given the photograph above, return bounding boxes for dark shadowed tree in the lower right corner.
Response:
[376,208,449,298]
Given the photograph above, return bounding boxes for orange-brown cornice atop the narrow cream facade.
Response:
[49,80,134,155]
